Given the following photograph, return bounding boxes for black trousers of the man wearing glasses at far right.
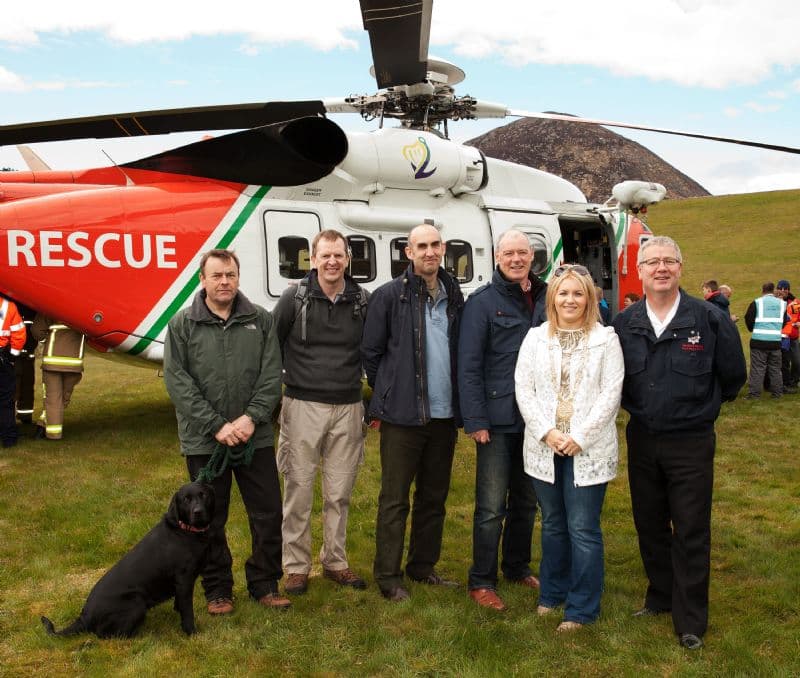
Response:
[627,420,716,636]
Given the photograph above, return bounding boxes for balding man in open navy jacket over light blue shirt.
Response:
[361,225,464,602]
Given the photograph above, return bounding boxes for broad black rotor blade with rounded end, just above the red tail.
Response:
[122,117,348,186]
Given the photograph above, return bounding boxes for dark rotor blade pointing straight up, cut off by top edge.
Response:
[361,0,433,89]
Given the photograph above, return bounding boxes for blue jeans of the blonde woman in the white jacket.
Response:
[533,455,608,624]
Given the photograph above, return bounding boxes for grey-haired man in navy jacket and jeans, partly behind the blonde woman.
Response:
[458,229,547,610]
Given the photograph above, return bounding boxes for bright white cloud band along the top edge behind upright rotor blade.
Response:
[0,0,800,88]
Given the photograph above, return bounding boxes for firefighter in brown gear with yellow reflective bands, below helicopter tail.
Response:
[32,313,84,440]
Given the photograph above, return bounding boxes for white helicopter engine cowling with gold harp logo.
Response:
[341,128,488,195]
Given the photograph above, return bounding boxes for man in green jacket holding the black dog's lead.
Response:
[164,250,290,614]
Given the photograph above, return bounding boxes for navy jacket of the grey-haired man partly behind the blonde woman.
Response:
[458,268,547,433]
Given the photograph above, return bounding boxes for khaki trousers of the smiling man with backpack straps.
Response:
[277,396,364,574]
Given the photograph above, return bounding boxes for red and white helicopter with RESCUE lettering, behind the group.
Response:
[0,0,800,362]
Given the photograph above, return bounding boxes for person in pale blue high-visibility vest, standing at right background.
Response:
[744,282,786,400]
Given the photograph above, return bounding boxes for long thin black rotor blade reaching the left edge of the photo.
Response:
[0,100,325,146]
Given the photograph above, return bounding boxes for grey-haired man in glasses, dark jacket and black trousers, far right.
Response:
[613,236,747,650]
